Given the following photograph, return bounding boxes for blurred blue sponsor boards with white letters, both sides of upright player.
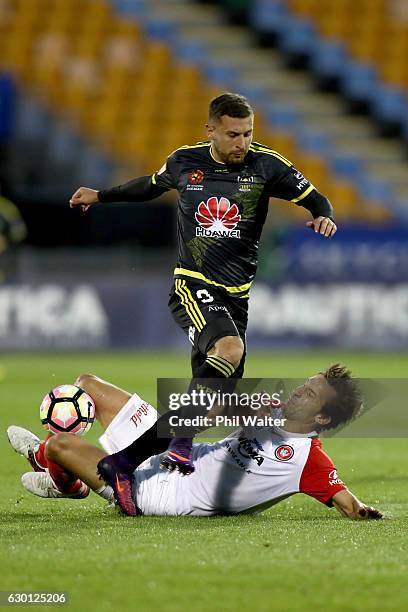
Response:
[0,279,408,351]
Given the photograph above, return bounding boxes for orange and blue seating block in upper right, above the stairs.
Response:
[251,0,408,134]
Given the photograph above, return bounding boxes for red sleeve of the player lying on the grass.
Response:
[299,438,347,506]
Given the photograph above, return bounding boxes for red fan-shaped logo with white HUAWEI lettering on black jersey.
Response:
[195,196,241,238]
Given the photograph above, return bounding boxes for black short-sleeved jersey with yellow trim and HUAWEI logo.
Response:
[152,142,314,297]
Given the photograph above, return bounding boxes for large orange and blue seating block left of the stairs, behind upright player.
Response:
[0,0,398,221]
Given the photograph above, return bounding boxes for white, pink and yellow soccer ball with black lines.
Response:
[40,385,95,436]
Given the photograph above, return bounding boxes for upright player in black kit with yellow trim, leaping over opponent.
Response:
[70,93,337,515]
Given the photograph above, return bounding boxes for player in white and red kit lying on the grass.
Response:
[8,365,382,519]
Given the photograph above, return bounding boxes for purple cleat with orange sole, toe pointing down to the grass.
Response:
[98,455,138,516]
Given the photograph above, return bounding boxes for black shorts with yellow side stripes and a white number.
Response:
[169,278,248,377]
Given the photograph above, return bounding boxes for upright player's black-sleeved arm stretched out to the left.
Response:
[69,176,168,212]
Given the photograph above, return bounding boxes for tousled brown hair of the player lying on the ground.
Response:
[320,363,363,430]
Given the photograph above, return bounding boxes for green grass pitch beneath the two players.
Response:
[0,352,408,612]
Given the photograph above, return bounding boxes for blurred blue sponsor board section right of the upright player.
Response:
[248,282,408,350]
